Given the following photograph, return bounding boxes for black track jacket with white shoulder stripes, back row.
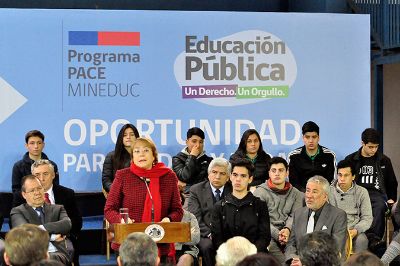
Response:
[288,145,336,192]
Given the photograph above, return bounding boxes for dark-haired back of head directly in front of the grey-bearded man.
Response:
[299,231,340,266]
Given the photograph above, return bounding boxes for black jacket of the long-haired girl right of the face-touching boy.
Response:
[229,150,271,186]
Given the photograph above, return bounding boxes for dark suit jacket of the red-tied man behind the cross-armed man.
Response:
[13,184,82,239]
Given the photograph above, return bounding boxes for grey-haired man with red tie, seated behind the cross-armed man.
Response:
[14,159,82,266]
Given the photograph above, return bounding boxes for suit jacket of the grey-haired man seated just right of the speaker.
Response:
[188,181,232,237]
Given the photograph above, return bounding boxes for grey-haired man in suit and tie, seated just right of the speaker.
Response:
[188,158,232,266]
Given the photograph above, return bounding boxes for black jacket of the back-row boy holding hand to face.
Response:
[172,151,212,187]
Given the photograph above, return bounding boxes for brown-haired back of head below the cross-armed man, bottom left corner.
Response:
[4,224,49,266]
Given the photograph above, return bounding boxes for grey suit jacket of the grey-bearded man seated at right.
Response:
[285,203,347,260]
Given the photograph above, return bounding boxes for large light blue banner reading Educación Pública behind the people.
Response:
[0,9,371,191]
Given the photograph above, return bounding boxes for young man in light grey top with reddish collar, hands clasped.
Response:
[254,157,304,264]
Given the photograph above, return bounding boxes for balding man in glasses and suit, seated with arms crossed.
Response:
[10,175,73,265]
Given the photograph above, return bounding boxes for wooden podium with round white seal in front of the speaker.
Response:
[110,222,191,244]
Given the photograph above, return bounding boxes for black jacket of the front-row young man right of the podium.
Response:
[211,192,271,252]
